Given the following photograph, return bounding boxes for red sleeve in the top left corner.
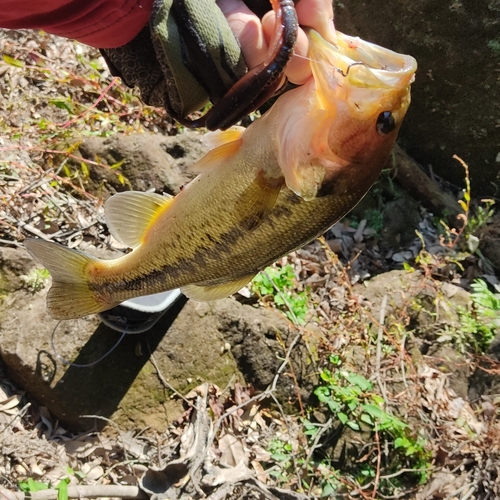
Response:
[0,0,153,49]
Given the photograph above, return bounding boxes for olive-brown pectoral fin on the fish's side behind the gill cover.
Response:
[236,170,285,231]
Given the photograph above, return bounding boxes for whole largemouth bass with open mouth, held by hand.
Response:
[25,31,416,319]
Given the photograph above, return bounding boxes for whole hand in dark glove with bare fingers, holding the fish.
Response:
[102,0,333,124]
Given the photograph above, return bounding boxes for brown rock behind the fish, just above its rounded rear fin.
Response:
[75,131,208,195]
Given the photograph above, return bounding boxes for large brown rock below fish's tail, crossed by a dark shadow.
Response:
[0,250,317,431]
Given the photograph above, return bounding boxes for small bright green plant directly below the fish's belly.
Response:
[251,264,308,325]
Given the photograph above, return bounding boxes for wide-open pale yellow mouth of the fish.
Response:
[309,30,417,89]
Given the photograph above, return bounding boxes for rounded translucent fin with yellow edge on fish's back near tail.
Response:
[104,191,174,248]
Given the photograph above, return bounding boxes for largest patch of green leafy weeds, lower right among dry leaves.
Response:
[267,355,431,498]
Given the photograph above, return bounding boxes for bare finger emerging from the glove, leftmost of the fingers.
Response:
[217,0,269,69]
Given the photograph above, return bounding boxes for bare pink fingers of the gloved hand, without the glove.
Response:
[217,0,333,85]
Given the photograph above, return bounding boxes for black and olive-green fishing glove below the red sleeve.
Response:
[101,0,254,118]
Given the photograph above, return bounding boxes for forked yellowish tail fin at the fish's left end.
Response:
[24,239,105,320]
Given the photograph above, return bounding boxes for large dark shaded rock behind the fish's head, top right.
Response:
[335,0,500,197]
